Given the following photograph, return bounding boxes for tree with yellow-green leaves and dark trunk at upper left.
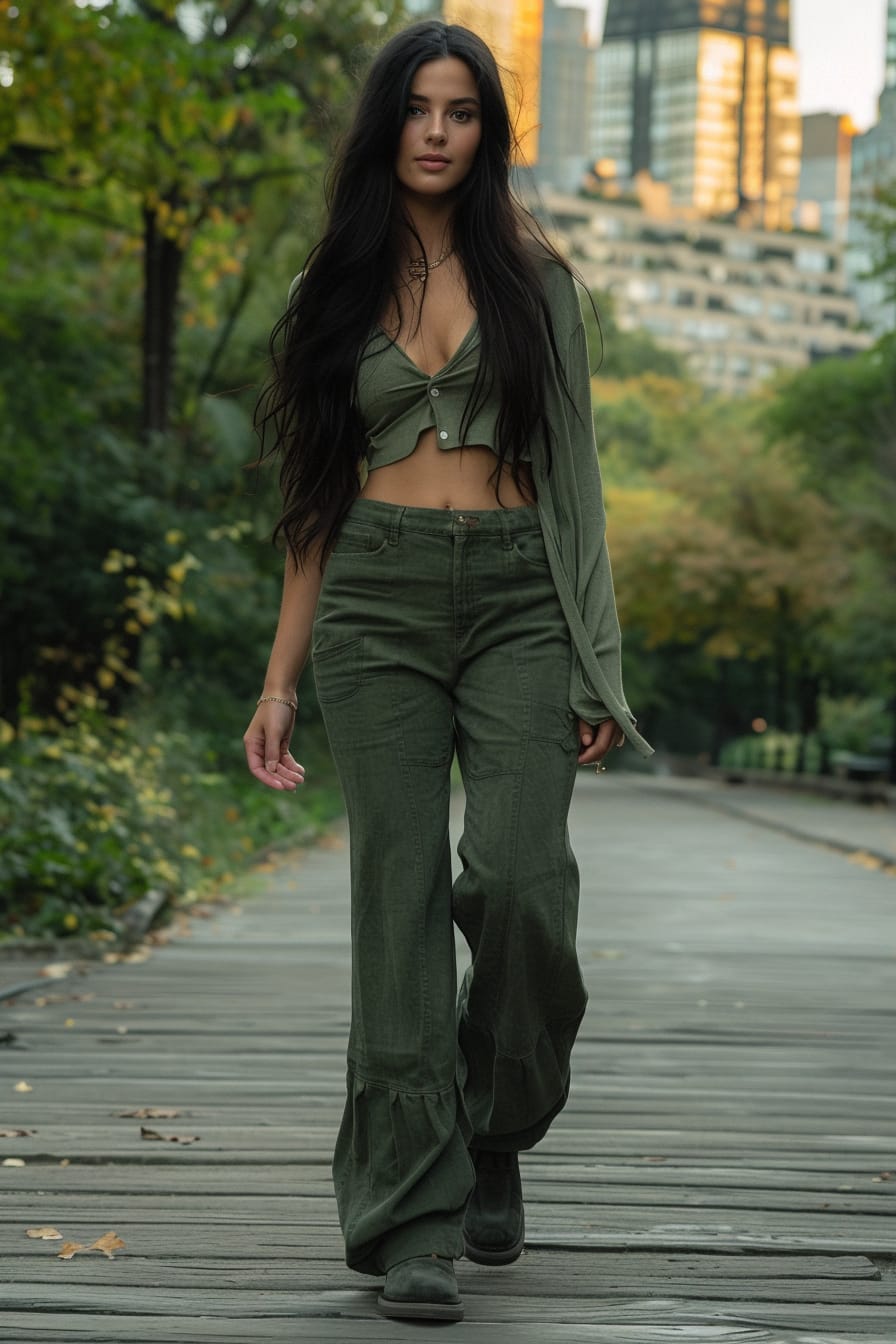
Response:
[0,0,395,435]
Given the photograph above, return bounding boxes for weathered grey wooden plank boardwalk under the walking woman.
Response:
[0,773,896,1344]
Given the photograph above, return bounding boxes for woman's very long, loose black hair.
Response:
[255,20,583,563]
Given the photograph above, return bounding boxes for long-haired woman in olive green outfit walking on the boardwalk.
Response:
[244,20,650,1320]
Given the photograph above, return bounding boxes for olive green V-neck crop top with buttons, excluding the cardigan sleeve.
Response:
[356,319,518,470]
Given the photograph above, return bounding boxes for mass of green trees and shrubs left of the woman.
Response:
[0,0,392,933]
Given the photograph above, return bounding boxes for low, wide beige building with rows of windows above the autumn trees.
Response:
[536,179,872,395]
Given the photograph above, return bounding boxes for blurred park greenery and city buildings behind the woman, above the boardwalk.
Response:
[0,0,896,941]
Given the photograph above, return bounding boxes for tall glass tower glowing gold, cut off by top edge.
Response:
[590,0,801,228]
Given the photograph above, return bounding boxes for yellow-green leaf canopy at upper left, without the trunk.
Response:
[0,0,394,228]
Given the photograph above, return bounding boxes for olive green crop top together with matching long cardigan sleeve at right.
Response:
[290,257,653,757]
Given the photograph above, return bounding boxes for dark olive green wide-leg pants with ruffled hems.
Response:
[313,500,586,1274]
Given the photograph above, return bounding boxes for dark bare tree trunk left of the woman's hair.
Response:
[141,202,184,438]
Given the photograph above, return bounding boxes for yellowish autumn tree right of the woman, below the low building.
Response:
[607,402,850,746]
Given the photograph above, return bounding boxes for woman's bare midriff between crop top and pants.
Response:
[361,429,536,509]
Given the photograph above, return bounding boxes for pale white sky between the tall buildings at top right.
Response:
[560,0,887,130]
